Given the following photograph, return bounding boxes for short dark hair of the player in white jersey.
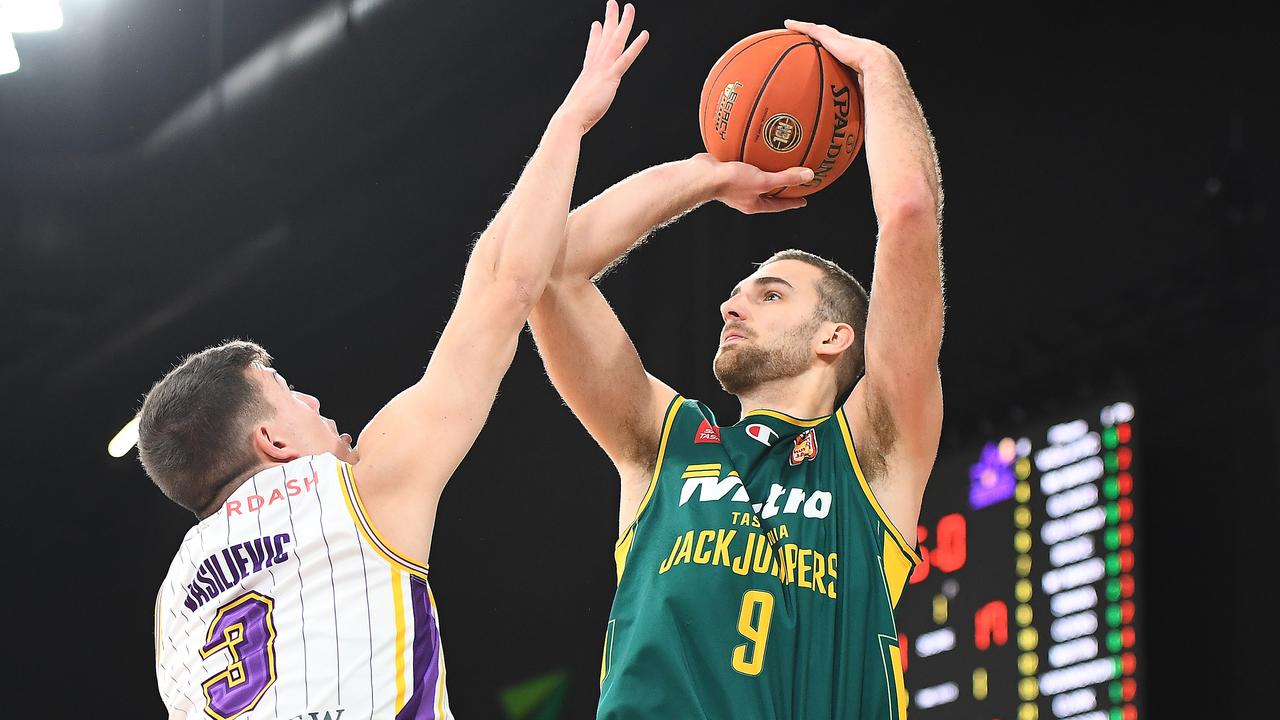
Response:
[138,341,274,515]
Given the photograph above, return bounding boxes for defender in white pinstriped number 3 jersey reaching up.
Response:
[138,0,648,720]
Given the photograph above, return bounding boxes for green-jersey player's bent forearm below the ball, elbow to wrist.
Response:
[556,156,718,281]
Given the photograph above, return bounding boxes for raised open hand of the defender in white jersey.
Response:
[561,0,649,133]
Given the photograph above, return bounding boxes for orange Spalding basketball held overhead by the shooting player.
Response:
[698,29,863,197]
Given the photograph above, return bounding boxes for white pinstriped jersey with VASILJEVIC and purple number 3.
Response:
[156,454,453,720]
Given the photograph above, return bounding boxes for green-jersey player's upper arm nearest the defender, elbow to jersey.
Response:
[529,278,676,477]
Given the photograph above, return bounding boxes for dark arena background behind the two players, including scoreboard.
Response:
[0,0,1280,720]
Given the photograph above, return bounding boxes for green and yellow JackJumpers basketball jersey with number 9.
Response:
[596,397,919,720]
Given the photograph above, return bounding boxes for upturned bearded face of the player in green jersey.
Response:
[714,260,822,395]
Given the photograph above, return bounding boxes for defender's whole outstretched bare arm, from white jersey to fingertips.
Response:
[356,0,648,560]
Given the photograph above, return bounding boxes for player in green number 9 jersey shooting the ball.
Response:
[530,20,943,720]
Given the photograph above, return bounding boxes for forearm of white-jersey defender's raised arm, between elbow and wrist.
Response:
[467,113,582,303]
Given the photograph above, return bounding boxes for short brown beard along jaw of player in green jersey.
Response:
[713,318,818,395]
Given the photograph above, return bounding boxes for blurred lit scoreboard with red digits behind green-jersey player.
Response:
[896,397,1143,720]
